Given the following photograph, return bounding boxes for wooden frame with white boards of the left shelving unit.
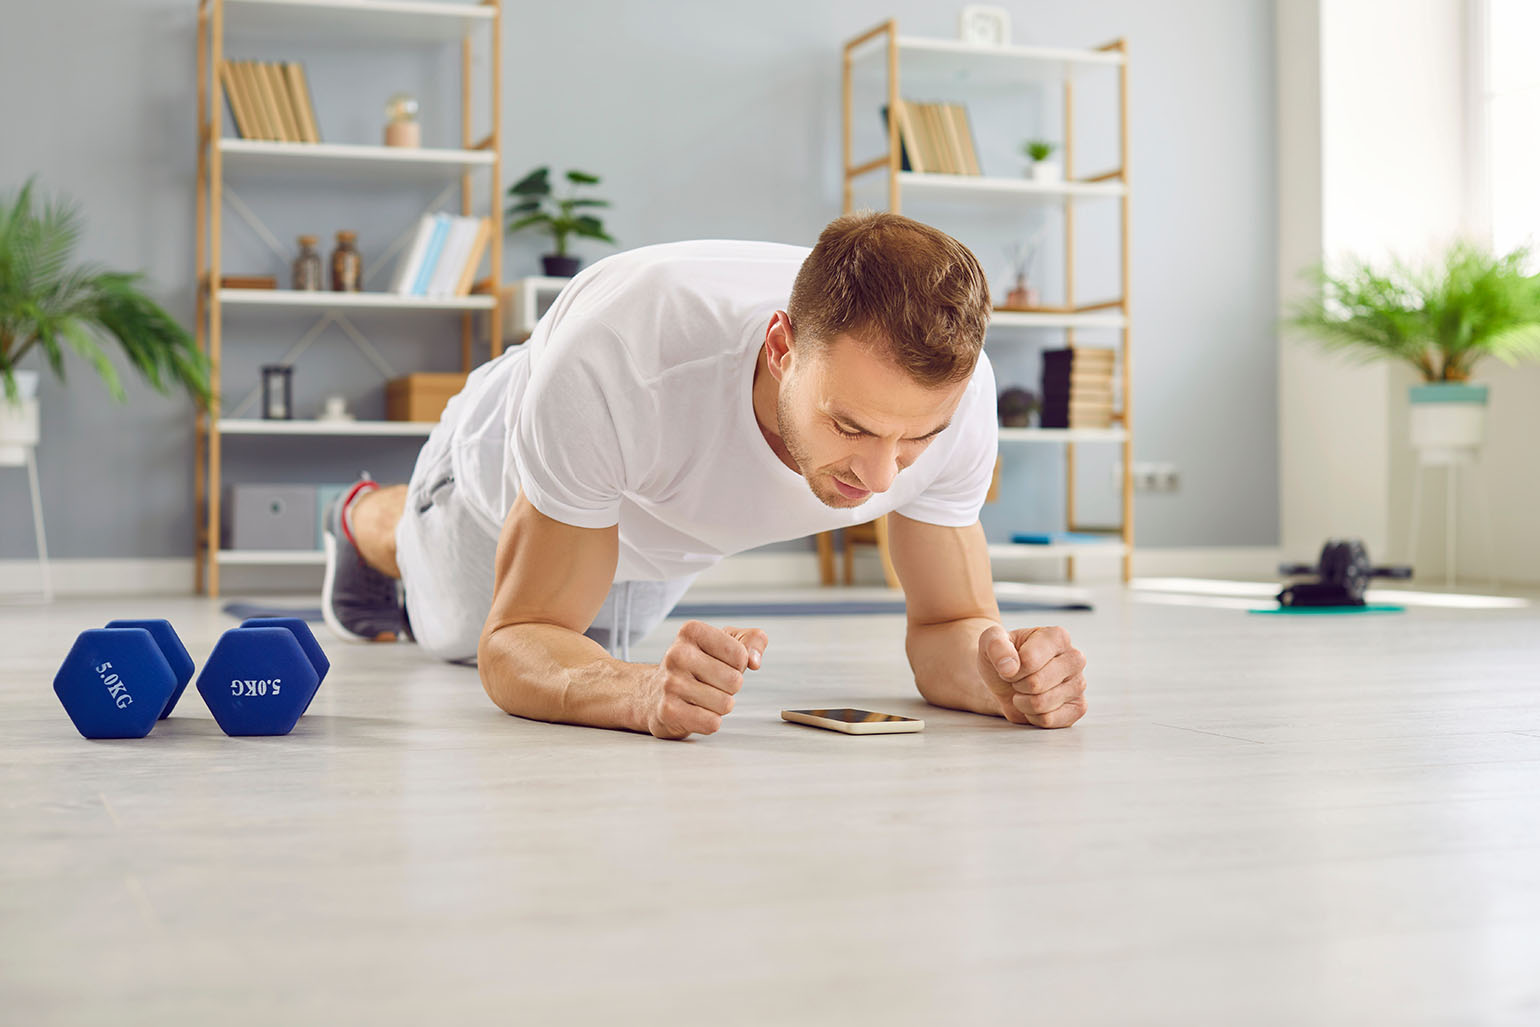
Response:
[193,0,504,596]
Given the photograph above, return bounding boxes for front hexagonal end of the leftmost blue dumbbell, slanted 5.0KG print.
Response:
[54,628,177,738]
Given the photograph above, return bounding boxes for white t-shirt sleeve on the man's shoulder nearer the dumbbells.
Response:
[510,316,648,528]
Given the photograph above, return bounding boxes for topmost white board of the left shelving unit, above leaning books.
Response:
[225,0,494,43]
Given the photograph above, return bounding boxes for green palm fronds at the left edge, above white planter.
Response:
[0,177,209,403]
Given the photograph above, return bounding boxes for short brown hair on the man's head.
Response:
[787,211,990,388]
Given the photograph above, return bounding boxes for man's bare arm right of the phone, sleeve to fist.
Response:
[889,513,1086,727]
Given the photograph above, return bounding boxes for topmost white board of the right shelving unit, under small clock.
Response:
[852,35,1126,91]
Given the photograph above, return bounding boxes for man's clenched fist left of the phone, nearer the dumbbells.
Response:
[639,621,770,739]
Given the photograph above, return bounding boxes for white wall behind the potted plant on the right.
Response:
[1277,0,1540,582]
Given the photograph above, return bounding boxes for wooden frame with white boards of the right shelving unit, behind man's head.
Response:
[843,18,1133,587]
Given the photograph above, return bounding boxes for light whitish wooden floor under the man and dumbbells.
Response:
[0,590,1540,1025]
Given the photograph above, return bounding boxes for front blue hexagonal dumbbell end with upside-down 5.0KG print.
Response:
[197,628,320,734]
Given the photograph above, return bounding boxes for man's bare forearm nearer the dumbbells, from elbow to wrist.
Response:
[477,624,653,731]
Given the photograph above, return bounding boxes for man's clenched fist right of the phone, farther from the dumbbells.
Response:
[978,624,1086,727]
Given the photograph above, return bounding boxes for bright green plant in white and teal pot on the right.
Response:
[1289,242,1540,463]
